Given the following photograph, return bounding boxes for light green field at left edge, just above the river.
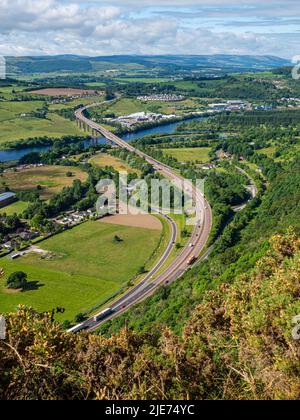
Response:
[0,101,83,143]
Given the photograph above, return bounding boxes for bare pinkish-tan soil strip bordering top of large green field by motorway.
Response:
[100,214,162,231]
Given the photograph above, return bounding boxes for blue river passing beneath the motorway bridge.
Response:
[0,117,203,162]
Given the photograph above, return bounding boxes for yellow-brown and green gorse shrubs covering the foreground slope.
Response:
[0,232,300,399]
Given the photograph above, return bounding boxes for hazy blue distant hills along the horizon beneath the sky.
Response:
[7,55,290,75]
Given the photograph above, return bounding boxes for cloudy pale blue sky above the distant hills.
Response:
[0,0,300,58]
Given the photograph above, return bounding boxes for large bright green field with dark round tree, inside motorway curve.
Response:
[0,222,161,321]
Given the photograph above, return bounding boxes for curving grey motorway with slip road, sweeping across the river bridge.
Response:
[70,104,212,332]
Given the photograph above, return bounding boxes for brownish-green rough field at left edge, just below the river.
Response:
[0,166,87,200]
